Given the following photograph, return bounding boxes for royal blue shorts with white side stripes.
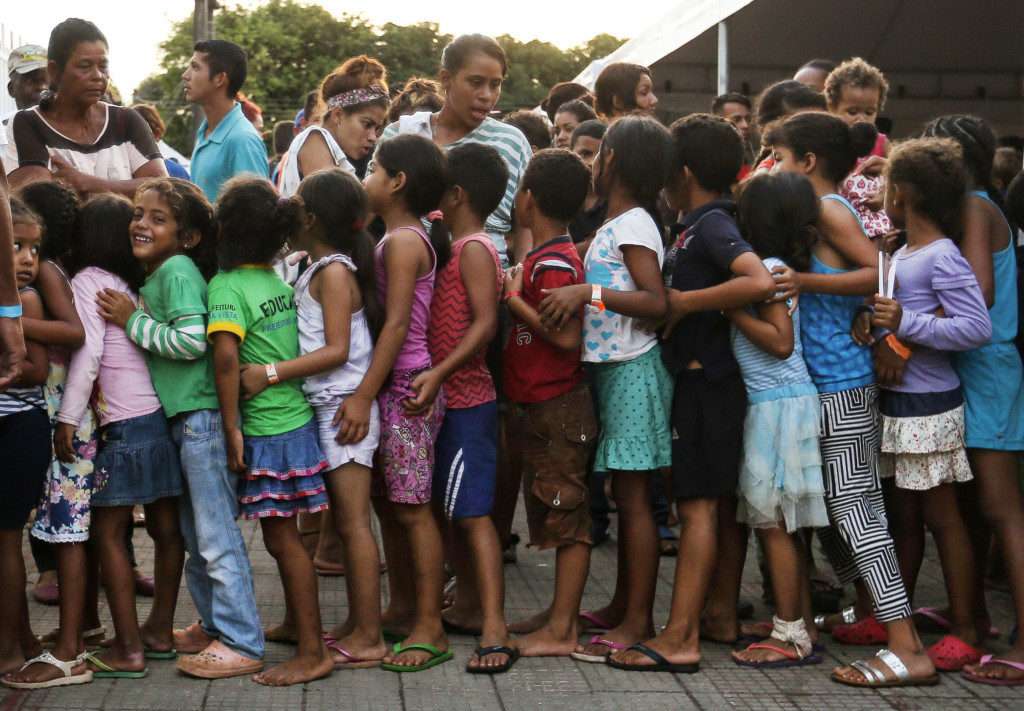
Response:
[433,401,498,520]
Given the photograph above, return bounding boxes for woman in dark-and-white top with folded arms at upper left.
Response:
[4,17,167,197]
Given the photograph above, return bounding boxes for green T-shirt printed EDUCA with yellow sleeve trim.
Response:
[206,265,313,436]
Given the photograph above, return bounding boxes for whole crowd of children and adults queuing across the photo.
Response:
[0,13,1024,700]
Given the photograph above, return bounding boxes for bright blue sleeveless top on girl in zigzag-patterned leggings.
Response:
[800,194,874,392]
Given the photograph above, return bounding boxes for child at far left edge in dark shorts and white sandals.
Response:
[0,199,52,688]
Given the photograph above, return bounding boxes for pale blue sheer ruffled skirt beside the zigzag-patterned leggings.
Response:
[736,392,828,532]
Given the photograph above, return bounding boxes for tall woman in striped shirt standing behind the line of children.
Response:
[382,35,532,266]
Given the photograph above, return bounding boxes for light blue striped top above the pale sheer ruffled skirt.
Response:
[731,257,817,405]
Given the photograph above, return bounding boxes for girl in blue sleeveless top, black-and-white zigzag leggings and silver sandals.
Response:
[765,113,938,686]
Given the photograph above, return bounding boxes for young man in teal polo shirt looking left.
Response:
[181,40,269,203]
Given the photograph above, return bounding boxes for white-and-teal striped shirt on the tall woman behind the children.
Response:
[381,111,534,267]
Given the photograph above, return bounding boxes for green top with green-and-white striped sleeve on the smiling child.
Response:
[125,254,217,417]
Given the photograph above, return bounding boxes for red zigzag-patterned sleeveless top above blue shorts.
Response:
[427,234,502,410]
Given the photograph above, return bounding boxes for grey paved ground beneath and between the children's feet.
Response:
[0,512,1024,711]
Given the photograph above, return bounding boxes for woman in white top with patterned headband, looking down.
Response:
[281,54,390,197]
